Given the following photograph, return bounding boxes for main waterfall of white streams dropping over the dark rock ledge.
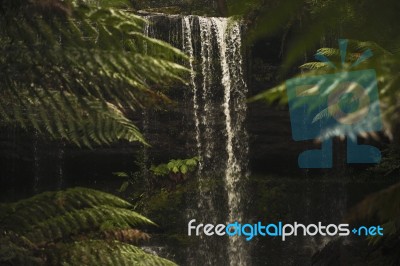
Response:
[182,16,249,265]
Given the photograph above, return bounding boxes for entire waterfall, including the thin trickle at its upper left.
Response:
[146,14,250,265]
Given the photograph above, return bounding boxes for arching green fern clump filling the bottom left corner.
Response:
[0,188,175,265]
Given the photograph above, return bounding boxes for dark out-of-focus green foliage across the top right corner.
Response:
[228,0,400,70]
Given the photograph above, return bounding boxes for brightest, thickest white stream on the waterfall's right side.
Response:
[214,19,247,265]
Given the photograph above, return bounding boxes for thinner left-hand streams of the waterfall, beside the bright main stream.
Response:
[182,16,223,265]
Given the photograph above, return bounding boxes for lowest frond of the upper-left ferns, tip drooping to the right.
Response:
[0,90,146,147]
